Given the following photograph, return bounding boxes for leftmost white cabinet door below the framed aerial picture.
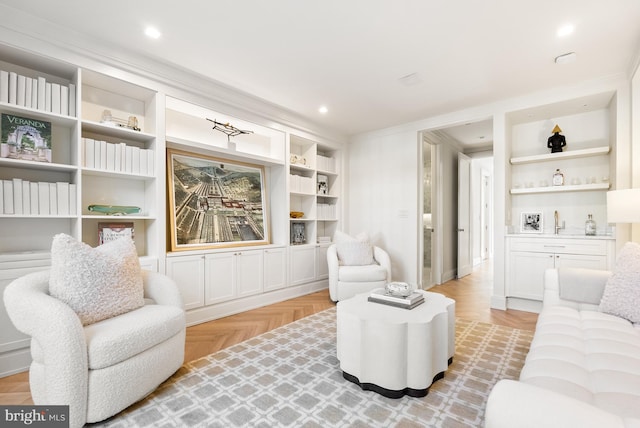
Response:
[167,255,204,310]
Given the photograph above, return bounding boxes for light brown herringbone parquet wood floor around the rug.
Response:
[0,262,538,405]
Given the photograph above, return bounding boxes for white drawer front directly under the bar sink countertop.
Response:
[510,238,607,255]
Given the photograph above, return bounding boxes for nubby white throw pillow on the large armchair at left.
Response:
[49,233,144,325]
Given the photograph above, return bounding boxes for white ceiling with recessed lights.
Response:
[0,0,640,135]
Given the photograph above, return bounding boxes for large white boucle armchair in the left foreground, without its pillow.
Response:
[4,271,186,427]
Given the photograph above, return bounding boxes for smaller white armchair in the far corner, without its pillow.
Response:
[327,244,391,302]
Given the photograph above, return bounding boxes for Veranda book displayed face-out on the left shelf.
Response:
[0,113,51,163]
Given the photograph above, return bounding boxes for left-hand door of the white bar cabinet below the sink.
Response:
[507,251,554,300]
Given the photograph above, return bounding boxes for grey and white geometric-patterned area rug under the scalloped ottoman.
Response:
[92,308,533,428]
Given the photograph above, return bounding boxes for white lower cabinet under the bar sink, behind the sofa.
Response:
[507,237,615,301]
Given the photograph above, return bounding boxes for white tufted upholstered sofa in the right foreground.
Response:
[485,260,640,428]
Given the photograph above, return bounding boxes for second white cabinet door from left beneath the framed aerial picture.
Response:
[204,253,236,305]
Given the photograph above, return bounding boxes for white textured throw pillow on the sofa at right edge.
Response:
[600,242,640,323]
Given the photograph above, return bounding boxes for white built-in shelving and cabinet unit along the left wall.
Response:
[0,46,342,376]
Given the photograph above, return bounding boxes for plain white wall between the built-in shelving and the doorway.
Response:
[345,131,422,283]
